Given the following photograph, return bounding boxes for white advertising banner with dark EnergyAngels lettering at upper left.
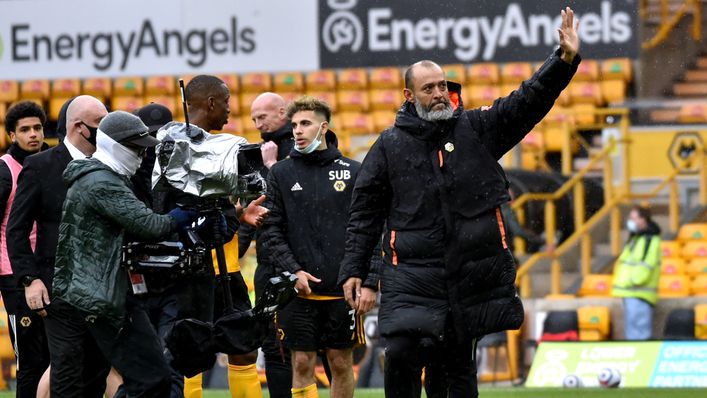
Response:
[0,0,319,80]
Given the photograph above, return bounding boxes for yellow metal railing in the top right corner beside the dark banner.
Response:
[639,0,702,49]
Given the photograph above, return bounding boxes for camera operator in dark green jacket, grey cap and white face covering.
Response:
[46,111,196,398]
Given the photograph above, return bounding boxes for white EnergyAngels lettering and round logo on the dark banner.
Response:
[321,0,632,62]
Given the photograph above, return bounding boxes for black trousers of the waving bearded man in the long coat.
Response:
[384,328,479,398]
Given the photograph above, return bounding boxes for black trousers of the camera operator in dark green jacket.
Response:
[45,299,171,398]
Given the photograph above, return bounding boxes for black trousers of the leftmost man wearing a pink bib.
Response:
[2,289,49,398]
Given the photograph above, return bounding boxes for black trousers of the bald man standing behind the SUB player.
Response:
[254,264,292,398]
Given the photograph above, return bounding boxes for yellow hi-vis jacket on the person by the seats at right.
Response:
[611,235,661,304]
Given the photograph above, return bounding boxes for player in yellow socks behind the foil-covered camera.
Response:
[155,75,267,398]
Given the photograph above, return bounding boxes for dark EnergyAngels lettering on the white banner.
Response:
[0,16,256,71]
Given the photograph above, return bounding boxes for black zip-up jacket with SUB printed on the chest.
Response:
[261,132,380,297]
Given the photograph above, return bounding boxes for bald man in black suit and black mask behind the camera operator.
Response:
[7,95,107,397]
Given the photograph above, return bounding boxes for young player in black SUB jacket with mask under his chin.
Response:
[262,97,378,398]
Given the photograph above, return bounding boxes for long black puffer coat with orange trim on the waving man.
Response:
[340,49,580,339]
